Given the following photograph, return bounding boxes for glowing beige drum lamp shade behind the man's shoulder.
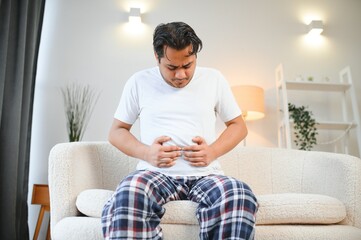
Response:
[232,85,265,121]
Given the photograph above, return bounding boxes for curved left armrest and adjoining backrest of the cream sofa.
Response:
[48,142,136,233]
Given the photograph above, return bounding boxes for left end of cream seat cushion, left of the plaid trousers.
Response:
[75,189,114,217]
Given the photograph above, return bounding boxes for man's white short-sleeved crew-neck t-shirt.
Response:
[114,67,241,176]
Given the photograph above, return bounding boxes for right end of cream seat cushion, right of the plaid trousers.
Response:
[257,193,346,225]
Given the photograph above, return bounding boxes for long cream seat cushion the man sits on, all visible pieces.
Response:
[76,189,346,225]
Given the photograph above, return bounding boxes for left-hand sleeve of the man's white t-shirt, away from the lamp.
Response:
[114,76,140,124]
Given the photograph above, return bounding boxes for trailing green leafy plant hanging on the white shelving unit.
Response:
[288,103,318,151]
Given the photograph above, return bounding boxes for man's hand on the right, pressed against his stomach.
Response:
[183,137,217,167]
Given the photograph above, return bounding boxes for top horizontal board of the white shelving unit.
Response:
[285,81,351,92]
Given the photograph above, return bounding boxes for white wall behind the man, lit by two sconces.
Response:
[29,0,361,236]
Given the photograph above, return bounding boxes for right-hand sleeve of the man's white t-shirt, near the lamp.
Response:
[216,74,242,122]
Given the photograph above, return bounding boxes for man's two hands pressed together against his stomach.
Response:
[145,136,216,168]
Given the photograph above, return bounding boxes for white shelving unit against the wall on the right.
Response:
[275,64,361,156]
